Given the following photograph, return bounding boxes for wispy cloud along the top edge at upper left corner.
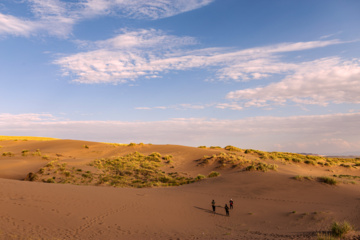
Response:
[0,0,213,38]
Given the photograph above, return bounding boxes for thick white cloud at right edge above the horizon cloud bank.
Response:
[227,57,360,107]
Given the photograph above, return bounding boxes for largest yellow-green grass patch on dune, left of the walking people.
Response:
[25,152,219,188]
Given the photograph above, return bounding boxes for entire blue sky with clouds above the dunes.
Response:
[0,0,360,155]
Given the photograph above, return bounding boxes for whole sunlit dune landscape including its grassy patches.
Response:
[0,136,360,240]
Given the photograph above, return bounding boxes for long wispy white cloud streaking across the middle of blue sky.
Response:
[55,29,342,84]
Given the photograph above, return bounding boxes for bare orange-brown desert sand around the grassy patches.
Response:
[0,140,360,240]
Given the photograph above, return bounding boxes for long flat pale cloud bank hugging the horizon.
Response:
[0,112,360,153]
